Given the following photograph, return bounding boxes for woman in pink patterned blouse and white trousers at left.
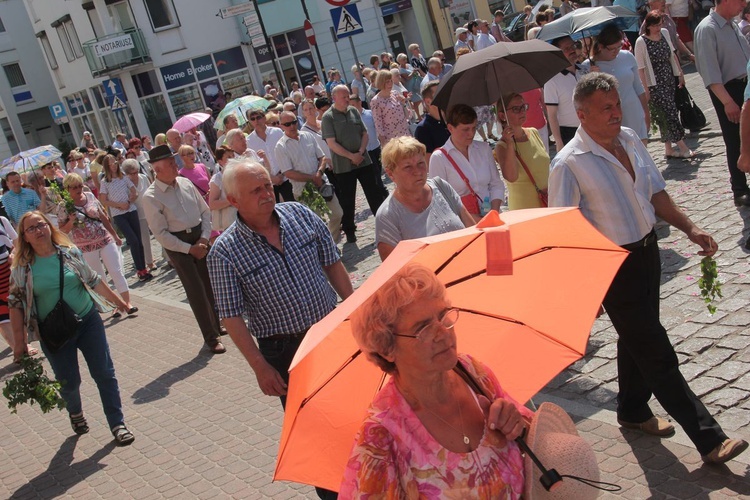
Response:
[57,173,138,317]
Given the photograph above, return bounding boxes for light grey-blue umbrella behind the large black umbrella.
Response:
[537,6,640,41]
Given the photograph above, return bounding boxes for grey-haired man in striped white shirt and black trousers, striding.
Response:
[549,73,748,464]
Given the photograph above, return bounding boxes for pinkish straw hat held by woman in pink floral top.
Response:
[524,403,599,500]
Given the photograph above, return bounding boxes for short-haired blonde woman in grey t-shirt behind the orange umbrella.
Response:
[375,136,474,260]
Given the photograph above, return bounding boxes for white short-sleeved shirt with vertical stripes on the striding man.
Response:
[549,127,666,245]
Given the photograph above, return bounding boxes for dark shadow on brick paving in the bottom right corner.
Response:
[622,431,750,500]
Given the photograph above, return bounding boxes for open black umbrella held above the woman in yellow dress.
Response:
[433,40,570,110]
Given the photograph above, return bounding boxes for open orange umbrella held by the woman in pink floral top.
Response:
[274,208,628,491]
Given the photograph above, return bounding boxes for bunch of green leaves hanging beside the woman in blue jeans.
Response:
[3,354,65,413]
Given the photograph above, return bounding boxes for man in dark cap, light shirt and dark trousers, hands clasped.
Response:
[143,144,226,354]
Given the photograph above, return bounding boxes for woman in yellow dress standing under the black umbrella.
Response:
[495,94,549,210]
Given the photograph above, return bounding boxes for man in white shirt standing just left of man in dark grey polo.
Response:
[274,111,344,244]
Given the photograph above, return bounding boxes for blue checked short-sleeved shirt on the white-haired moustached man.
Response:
[208,203,339,338]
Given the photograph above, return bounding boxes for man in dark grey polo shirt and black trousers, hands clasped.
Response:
[321,85,385,243]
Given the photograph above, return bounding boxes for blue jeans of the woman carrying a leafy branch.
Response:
[40,306,124,429]
